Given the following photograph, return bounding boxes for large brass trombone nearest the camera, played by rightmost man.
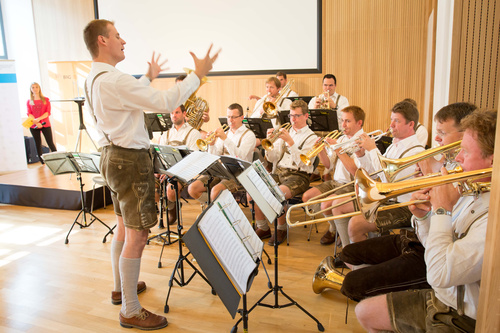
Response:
[286,168,493,227]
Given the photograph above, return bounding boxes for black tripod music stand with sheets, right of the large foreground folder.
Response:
[231,162,325,333]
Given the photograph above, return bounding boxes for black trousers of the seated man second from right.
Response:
[340,230,431,301]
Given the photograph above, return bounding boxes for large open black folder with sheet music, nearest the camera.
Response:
[183,190,264,318]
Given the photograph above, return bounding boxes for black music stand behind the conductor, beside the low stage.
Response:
[42,152,115,244]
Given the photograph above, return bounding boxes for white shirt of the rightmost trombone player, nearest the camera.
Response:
[414,193,490,319]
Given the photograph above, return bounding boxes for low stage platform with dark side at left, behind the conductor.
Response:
[0,165,111,210]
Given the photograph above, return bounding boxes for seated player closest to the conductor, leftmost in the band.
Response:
[157,105,201,224]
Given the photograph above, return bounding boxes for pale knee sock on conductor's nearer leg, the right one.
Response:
[120,257,142,318]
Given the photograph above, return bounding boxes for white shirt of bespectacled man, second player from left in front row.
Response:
[208,125,257,162]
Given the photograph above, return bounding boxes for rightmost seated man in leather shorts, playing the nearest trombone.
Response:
[356,110,497,332]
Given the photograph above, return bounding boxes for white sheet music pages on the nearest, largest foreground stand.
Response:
[198,190,263,295]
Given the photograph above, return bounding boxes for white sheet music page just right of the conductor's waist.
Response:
[167,151,219,182]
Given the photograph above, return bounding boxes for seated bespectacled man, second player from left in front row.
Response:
[188,103,256,202]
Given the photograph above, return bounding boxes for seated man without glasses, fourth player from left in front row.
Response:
[302,106,365,245]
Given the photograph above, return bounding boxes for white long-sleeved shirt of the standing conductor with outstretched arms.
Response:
[85,62,200,149]
